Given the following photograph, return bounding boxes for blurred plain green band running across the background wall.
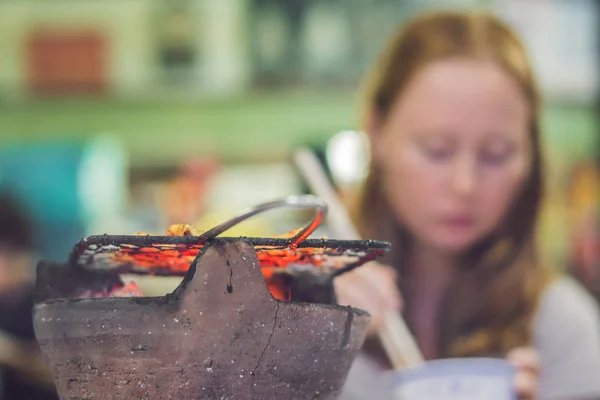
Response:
[0,92,598,167]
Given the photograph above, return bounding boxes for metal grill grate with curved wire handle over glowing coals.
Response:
[70,196,390,276]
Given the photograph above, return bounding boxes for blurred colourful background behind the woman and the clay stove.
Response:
[0,0,600,298]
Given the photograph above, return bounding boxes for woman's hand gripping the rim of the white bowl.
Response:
[506,347,541,400]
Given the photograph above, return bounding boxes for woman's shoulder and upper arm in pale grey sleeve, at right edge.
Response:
[534,277,600,399]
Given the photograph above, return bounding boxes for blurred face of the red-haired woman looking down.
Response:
[371,59,532,253]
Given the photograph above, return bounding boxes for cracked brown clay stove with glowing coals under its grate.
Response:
[34,195,388,400]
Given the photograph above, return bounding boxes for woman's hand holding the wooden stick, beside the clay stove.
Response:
[334,262,402,334]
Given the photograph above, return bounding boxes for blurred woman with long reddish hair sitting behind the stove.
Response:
[336,12,600,399]
